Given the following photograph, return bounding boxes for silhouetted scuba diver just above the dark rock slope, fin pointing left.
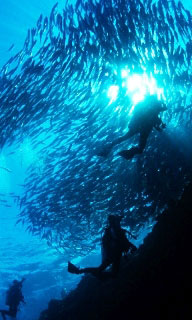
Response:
[68,215,137,279]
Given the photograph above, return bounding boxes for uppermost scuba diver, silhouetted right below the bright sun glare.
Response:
[98,95,167,160]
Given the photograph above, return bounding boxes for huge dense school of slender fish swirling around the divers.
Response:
[0,0,192,255]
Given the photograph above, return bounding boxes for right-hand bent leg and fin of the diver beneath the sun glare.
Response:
[118,130,150,160]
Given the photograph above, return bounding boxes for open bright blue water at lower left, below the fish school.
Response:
[0,145,79,320]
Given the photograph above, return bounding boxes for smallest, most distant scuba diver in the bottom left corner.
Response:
[0,278,25,320]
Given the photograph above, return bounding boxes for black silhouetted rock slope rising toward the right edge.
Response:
[40,184,192,320]
